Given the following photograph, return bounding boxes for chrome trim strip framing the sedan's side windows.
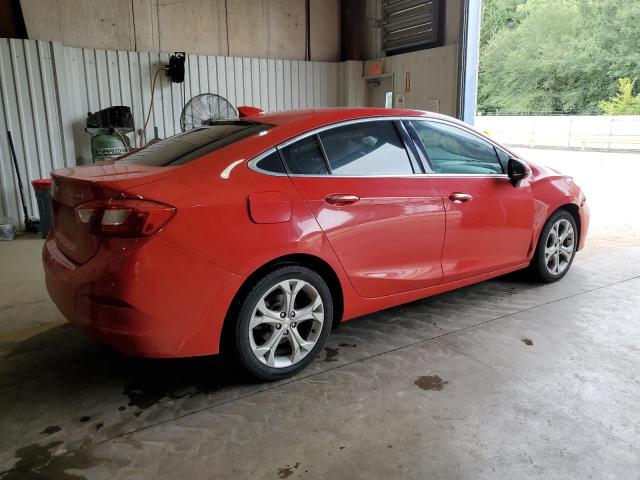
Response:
[247,116,511,179]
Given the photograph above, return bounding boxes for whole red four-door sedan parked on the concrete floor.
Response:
[43,108,589,379]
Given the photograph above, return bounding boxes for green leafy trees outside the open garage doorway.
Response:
[478,0,640,114]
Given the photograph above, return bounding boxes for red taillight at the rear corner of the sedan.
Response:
[76,198,176,237]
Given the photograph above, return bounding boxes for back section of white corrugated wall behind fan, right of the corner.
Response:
[63,47,339,163]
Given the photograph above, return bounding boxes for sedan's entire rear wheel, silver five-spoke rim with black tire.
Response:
[235,265,333,380]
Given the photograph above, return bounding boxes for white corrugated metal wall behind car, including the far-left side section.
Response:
[0,39,342,225]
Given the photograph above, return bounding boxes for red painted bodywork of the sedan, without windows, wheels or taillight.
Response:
[43,109,589,357]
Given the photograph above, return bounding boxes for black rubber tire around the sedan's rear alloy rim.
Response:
[231,265,333,381]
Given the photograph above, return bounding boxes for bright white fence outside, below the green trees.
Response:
[475,115,640,151]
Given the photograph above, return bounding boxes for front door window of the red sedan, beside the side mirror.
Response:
[409,120,503,175]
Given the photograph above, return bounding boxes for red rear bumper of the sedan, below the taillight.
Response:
[43,232,242,357]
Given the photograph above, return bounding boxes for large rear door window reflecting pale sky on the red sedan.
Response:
[320,121,413,176]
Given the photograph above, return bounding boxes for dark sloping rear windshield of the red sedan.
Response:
[118,120,271,167]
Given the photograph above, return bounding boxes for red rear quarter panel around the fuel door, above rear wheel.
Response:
[128,139,370,318]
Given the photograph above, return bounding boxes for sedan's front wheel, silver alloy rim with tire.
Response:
[530,210,578,283]
